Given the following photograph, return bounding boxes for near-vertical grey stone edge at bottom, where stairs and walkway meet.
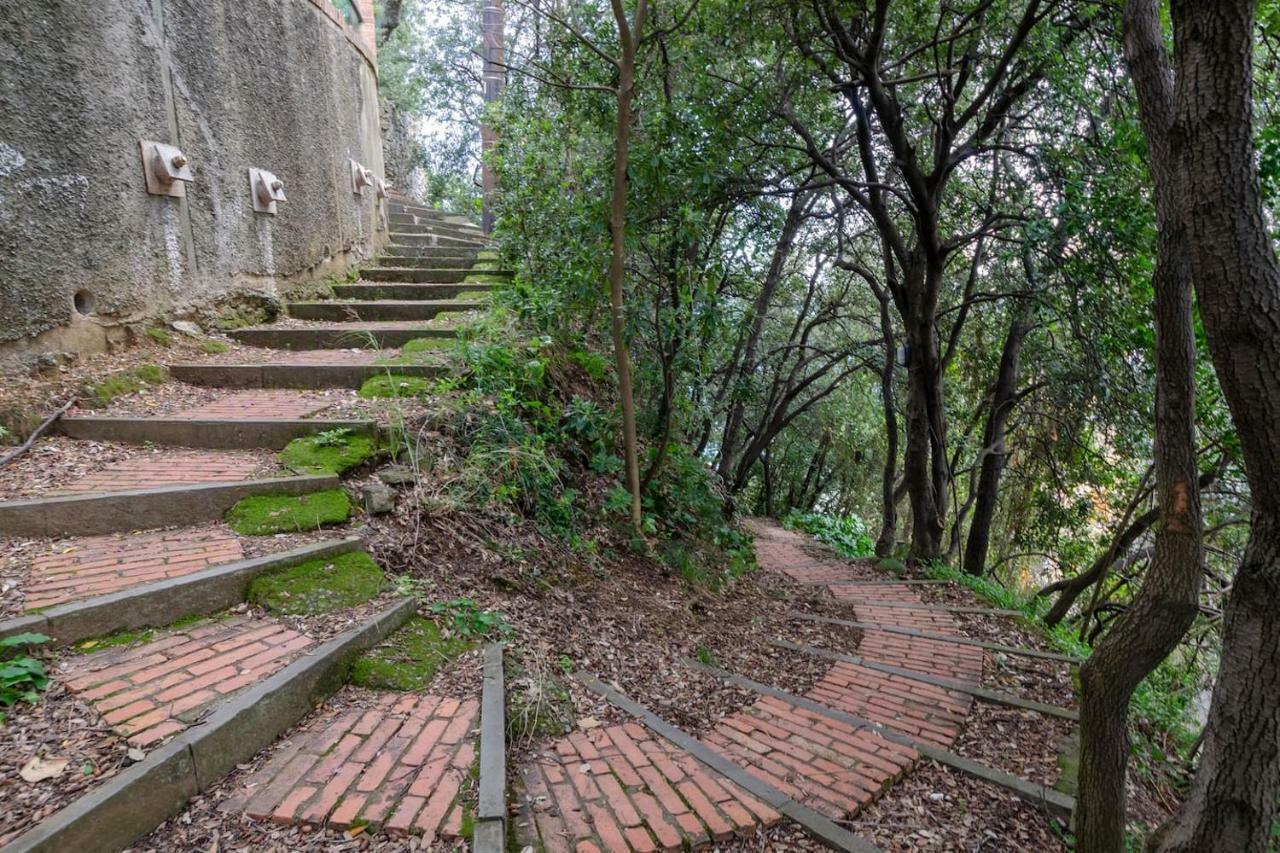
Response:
[471,643,507,853]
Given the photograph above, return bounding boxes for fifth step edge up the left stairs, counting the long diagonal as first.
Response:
[170,360,448,386]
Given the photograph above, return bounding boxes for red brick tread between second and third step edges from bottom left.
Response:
[26,528,244,610]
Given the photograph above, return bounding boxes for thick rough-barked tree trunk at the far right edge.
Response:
[1147,0,1280,852]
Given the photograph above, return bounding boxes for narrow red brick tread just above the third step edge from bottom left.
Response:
[46,451,261,496]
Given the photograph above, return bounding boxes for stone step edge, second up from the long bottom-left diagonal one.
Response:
[0,537,364,646]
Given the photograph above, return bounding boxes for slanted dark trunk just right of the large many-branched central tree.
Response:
[963,300,1032,575]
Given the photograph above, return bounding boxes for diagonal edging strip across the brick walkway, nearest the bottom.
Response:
[573,672,879,853]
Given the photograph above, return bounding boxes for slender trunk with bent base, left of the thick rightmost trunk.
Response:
[1075,0,1203,853]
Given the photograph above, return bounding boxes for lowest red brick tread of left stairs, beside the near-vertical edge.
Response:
[221,693,479,847]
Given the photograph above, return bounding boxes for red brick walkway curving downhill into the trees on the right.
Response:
[520,524,983,853]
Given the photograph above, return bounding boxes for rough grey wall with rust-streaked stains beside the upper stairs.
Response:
[0,0,383,362]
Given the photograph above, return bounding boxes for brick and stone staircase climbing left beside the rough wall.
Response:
[0,199,504,852]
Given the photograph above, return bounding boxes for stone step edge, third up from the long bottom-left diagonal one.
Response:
[0,474,340,538]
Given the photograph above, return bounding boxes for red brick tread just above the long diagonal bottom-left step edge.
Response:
[63,616,311,747]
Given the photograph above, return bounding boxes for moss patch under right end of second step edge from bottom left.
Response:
[248,551,387,615]
